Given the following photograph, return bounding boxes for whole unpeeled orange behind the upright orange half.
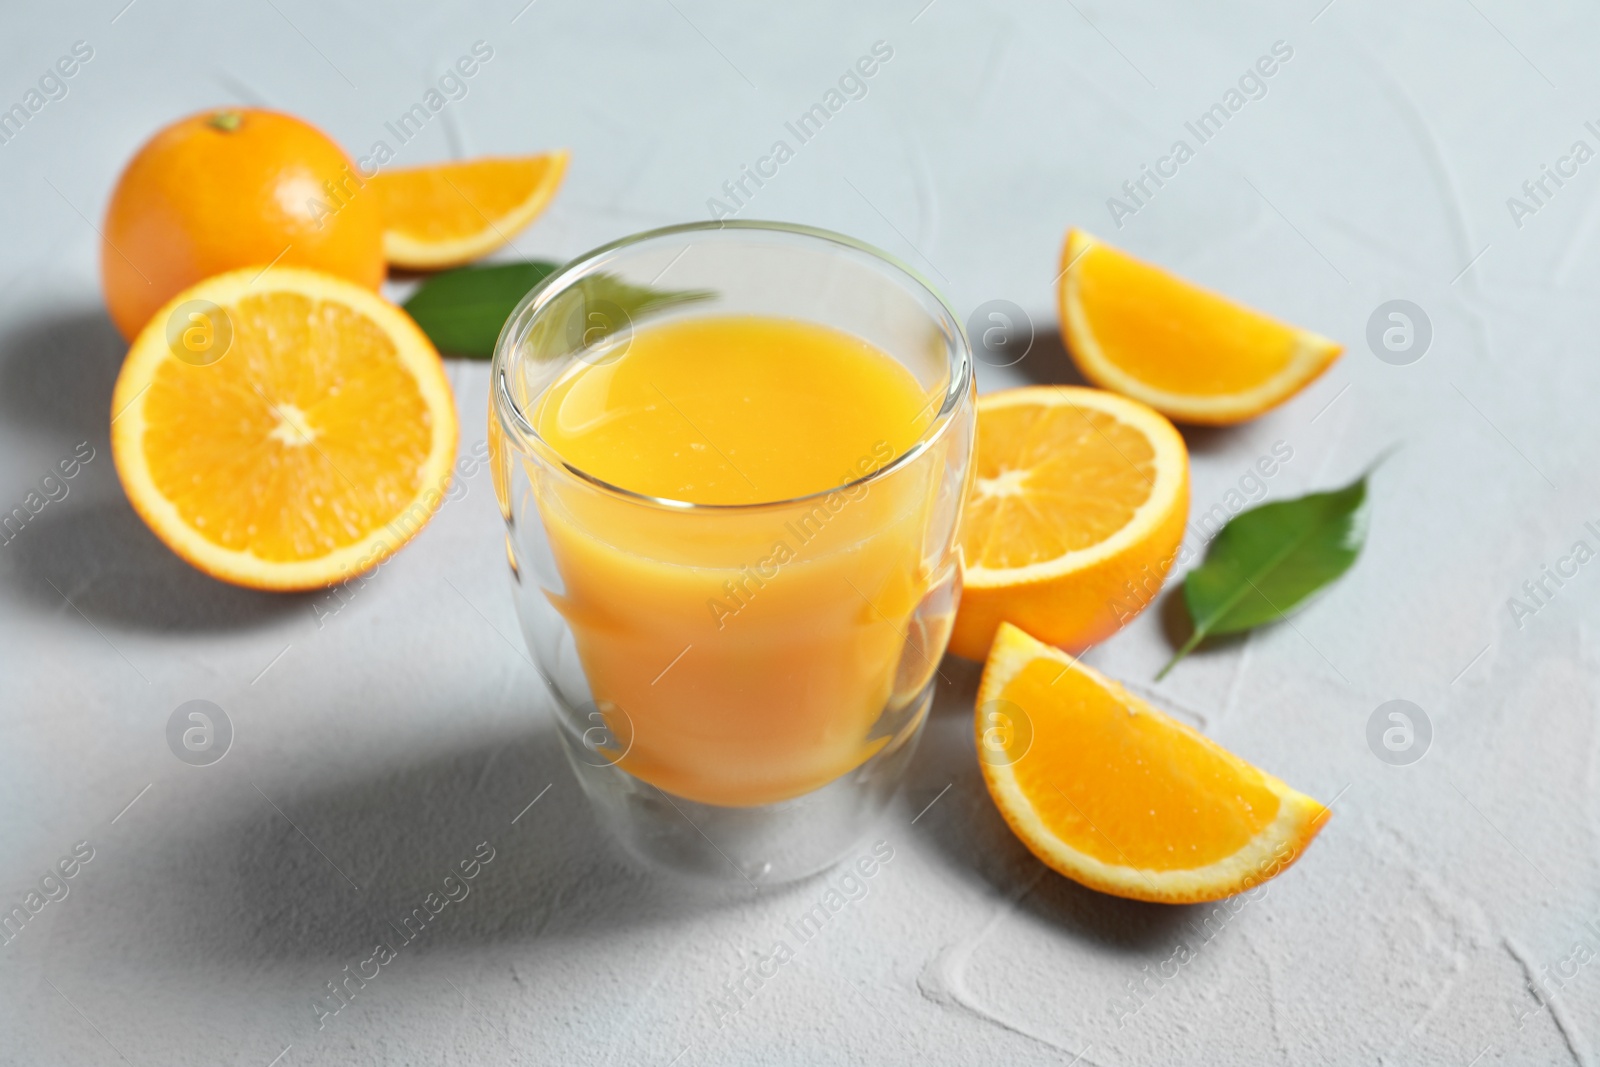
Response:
[101,107,384,341]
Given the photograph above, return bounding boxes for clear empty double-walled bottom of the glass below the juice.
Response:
[552,681,933,886]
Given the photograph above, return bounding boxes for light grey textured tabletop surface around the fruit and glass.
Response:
[0,0,1600,1067]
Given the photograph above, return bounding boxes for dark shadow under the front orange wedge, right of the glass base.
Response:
[907,656,1198,953]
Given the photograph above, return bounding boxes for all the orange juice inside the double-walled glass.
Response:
[533,317,949,806]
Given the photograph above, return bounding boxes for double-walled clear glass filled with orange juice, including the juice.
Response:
[490,222,974,883]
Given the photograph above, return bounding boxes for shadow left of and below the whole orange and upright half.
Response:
[0,307,306,630]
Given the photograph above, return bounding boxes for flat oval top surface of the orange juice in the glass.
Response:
[536,317,928,504]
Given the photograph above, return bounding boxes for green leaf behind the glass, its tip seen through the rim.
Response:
[405,261,715,360]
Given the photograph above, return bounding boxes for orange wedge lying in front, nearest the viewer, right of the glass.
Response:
[978,625,1331,904]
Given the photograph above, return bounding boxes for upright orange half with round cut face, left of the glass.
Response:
[110,267,456,590]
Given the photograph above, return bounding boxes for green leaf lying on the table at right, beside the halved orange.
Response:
[1155,470,1371,681]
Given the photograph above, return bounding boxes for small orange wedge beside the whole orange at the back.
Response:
[371,149,566,270]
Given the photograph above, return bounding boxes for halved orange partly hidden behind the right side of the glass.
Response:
[950,386,1189,659]
